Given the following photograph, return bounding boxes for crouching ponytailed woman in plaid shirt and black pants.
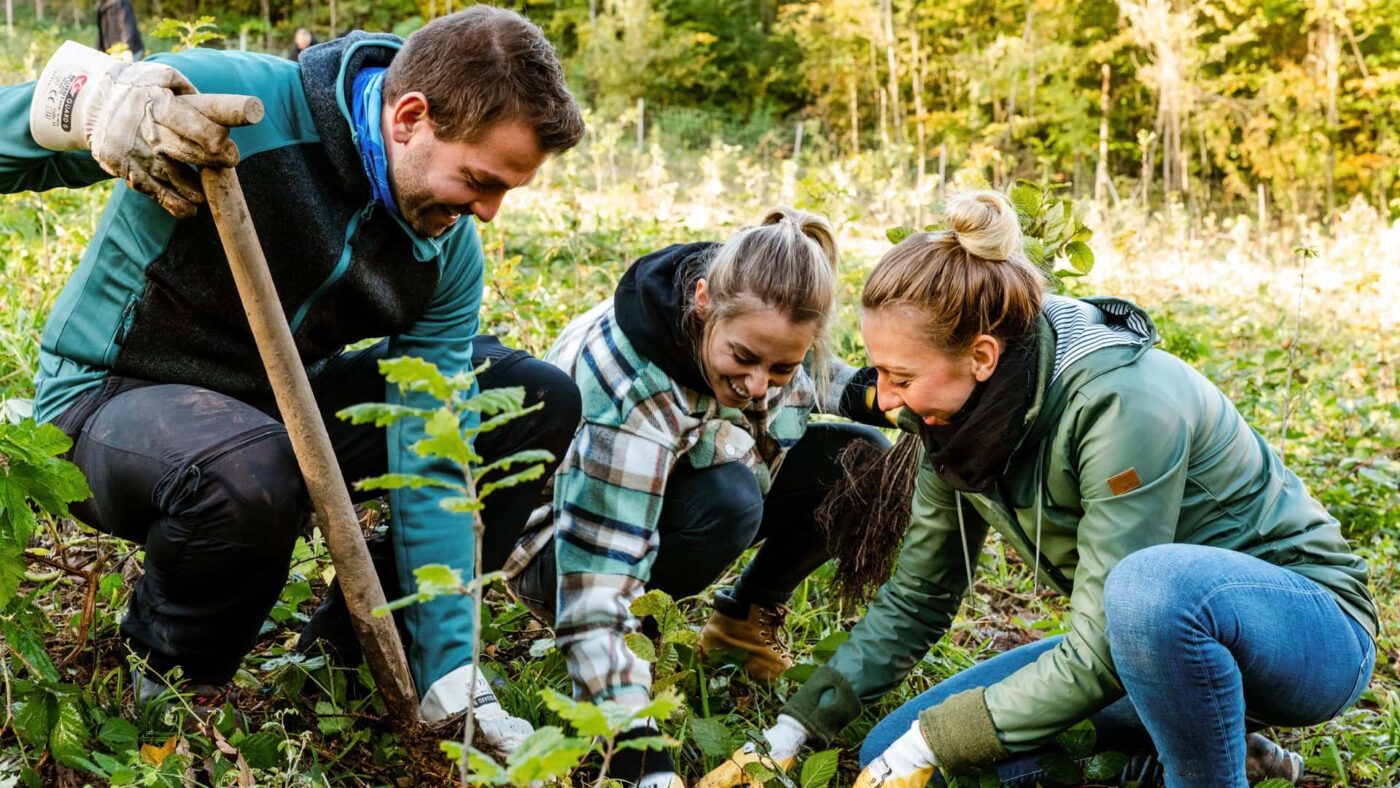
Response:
[505,209,888,785]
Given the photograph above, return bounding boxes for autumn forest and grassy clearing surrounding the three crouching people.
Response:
[0,0,1400,787]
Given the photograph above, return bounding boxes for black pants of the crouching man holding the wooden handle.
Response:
[55,337,580,684]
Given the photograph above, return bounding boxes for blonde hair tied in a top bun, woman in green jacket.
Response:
[861,192,1046,354]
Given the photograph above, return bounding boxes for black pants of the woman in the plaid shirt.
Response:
[515,423,889,612]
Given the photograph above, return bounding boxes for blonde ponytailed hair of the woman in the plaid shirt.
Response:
[689,207,839,386]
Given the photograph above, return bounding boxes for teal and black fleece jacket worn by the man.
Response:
[0,32,483,702]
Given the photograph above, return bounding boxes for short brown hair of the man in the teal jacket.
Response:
[384,6,584,154]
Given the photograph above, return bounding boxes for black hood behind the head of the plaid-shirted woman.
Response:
[613,244,720,393]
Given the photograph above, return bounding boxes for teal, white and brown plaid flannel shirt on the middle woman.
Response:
[505,300,854,707]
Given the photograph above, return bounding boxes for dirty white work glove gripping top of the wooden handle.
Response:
[29,41,244,218]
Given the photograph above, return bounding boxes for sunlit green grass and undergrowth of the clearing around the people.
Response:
[0,109,1400,787]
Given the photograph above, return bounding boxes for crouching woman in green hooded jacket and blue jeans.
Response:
[701,192,1378,788]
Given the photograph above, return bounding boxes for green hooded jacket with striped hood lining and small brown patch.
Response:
[783,297,1378,771]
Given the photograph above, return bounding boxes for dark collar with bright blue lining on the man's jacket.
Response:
[300,31,403,200]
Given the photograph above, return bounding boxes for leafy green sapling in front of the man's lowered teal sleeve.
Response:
[344,357,680,787]
